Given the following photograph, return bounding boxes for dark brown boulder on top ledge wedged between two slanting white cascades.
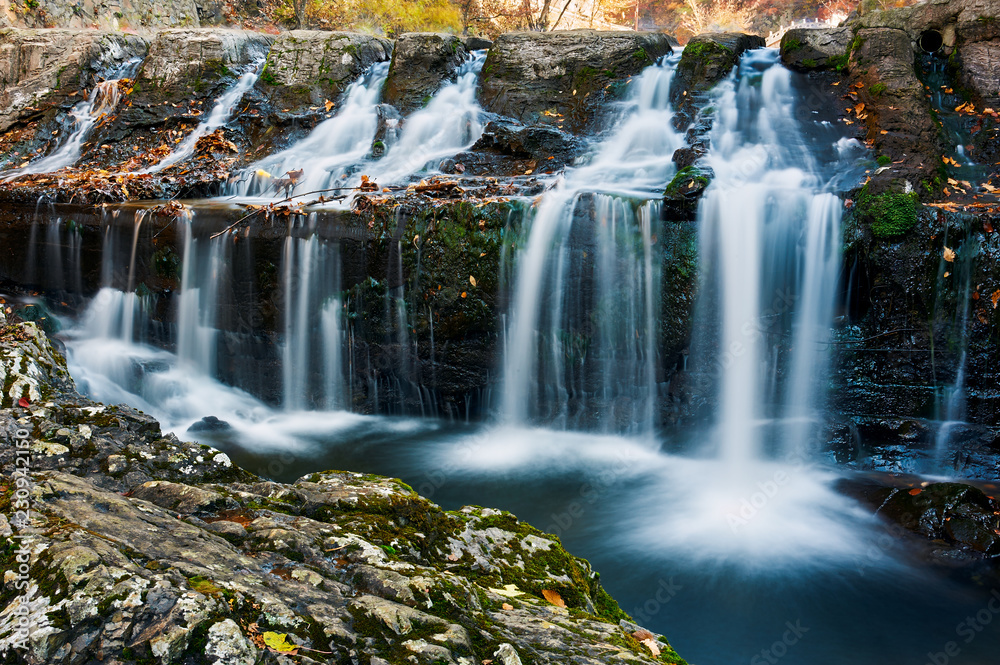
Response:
[382,32,469,114]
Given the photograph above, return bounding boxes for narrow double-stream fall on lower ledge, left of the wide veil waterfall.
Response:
[282,213,347,411]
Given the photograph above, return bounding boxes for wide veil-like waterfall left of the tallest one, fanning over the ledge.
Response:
[500,58,684,434]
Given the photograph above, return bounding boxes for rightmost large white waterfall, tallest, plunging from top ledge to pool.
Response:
[696,51,842,468]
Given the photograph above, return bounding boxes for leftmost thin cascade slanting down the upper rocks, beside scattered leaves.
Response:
[4,58,142,180]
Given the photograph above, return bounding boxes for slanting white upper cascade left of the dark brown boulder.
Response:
[232,62,389,197]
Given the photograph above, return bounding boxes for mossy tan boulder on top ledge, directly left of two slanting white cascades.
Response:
[258,30,392,108]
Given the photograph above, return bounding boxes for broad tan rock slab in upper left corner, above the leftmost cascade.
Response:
[0,28,149,132]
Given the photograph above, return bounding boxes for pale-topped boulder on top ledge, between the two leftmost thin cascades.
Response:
[136,29,274,101]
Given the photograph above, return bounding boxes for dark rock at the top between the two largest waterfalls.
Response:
[670,32,767,129]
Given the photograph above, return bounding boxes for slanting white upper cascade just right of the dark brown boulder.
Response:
[366,51,486,185]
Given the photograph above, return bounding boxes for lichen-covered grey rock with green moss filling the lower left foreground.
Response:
[0,314,684,665]
